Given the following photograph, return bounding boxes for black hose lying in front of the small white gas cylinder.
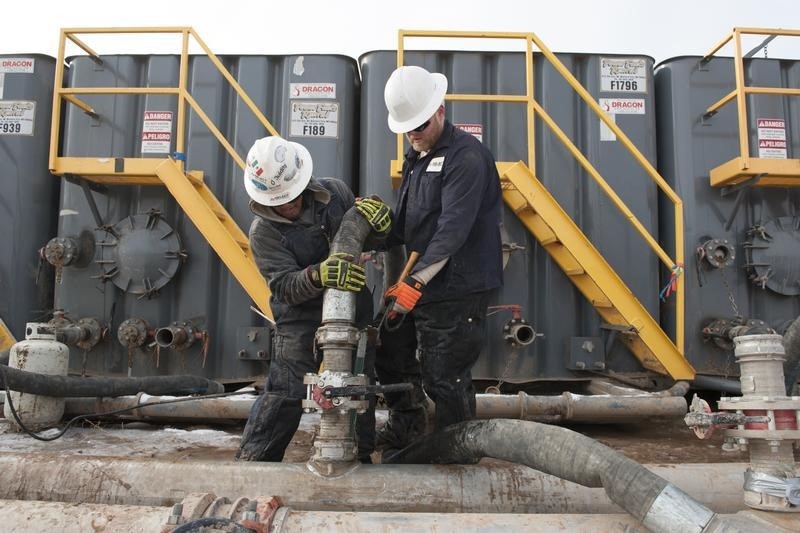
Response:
[0,365,225,398]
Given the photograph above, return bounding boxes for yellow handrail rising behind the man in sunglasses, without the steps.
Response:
[392,30,684,353]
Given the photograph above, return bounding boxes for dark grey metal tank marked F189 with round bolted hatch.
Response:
[56,55,359,381]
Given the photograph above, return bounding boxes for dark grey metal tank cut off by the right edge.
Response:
[655,56,800,376]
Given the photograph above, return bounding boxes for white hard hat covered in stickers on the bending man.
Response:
[244,137,314,206]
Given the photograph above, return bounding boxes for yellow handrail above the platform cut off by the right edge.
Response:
[700,28,800,170]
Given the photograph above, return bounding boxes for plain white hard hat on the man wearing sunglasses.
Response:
[383,67,447,133]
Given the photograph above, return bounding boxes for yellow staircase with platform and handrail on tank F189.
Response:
[50,27,278,318]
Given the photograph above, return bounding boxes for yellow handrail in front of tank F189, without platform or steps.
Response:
[48,27,280,171]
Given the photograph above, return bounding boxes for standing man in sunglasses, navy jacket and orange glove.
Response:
[376,66,503,453]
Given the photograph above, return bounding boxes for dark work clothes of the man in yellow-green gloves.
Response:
[236,178,375,461]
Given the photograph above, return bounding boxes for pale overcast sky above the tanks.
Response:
[0,0,800,61]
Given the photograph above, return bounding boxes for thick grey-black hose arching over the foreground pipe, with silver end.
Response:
[383,419,713,531]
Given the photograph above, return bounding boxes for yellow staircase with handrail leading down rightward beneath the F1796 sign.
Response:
[390,30,695,380]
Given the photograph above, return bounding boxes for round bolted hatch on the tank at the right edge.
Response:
[745,217,800,296]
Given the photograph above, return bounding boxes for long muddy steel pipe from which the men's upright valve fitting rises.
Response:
[0,453,745,513]
